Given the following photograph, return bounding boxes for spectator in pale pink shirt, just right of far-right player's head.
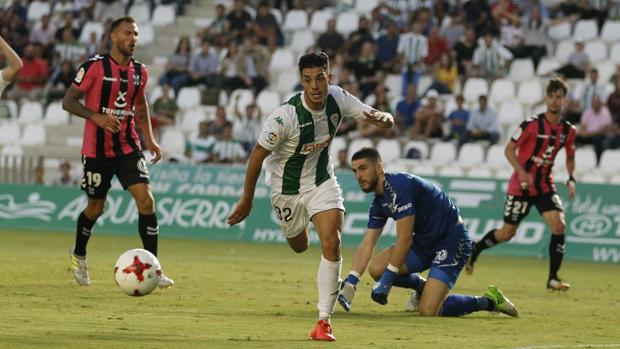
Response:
[576,95,613,164]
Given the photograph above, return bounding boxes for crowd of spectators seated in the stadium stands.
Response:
[0,0,620,170]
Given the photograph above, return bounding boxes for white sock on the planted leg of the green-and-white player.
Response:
[316,255,342,320]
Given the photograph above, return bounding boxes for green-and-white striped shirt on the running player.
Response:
[258,85,372,195]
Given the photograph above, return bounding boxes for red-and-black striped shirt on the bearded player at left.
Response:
[73,54,148,158]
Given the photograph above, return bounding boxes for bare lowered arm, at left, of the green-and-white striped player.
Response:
[228,144,271,225]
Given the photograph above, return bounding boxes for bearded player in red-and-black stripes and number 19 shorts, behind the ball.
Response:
[63,17,174,287]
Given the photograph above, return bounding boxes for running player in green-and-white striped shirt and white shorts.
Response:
[228,52,394,341]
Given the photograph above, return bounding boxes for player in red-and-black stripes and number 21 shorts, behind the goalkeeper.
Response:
[465,78,576,291]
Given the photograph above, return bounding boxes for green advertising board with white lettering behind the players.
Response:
[0,164,620,263]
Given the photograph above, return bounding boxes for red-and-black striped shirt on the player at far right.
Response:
[508,113,576,196]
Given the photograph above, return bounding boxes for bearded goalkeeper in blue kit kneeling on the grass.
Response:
[338,148,518,316]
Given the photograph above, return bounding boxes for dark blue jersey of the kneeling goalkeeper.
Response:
[368,172,460,247]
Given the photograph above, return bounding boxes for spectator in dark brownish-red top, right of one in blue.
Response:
[411,90,444,139]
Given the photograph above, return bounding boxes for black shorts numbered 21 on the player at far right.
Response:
[504,192,564,225]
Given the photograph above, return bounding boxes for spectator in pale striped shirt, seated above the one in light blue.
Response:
[472,31,513,80]
